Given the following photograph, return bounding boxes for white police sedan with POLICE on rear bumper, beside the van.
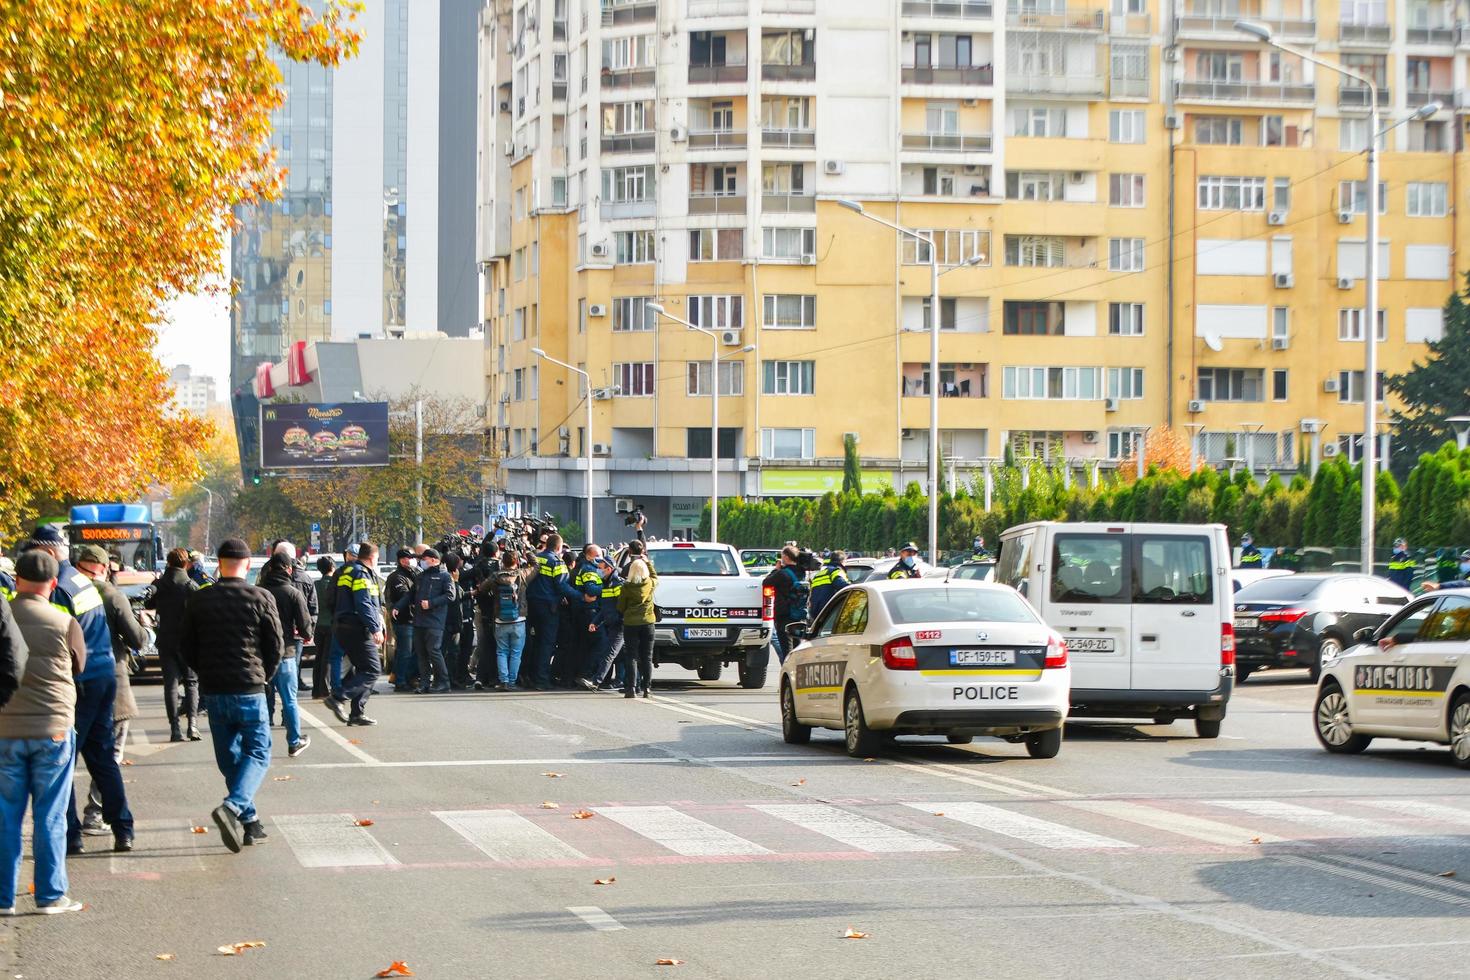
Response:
[781,579,1072,758]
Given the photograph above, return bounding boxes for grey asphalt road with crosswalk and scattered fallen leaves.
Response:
[0,667,1470,980]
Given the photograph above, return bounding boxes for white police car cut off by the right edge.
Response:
[1313,589,1470,768]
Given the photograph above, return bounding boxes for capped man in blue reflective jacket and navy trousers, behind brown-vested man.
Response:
[26,526,132,854]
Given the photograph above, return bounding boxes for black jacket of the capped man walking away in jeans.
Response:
[179,579,284,693]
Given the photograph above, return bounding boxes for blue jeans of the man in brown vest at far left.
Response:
[0,732,76,908]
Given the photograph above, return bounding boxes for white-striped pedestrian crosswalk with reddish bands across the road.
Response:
[71,796,1470,874]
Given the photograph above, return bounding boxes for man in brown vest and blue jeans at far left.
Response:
[0,550,87,915]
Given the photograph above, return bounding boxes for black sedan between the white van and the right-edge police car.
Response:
[1235,573,1413,685]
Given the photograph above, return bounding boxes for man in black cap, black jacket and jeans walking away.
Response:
[179,538,285,854]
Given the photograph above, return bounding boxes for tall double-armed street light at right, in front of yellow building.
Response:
[1235,21,1441,574]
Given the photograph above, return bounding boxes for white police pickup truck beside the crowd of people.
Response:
[648,541,775,688]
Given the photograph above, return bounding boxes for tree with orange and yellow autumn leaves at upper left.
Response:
[0,0,359,535]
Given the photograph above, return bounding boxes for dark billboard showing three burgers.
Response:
[260,401,388,469]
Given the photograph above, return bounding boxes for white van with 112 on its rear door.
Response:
[995,522,1235,739]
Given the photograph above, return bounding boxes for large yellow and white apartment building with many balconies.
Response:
[478,0,1470,537]
